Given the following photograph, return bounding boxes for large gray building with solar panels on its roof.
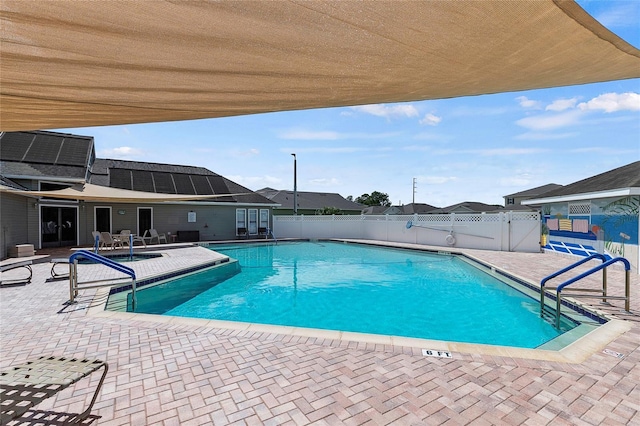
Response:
[0,131,279,258]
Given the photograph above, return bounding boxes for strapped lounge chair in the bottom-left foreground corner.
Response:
[0,356,109,424]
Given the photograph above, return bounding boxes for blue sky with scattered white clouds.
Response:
[60,0,640,207]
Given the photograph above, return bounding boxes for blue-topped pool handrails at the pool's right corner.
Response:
[540,253,631,329]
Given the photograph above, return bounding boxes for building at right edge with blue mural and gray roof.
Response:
[522,161,640,271]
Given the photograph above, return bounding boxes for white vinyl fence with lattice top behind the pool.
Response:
[273,212,540,252]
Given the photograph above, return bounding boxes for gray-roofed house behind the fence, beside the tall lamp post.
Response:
[256,188,364,215]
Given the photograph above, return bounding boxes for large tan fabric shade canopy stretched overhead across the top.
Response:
[0,0,640,131]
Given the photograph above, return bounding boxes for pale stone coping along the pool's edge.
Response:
[87,239,632,364]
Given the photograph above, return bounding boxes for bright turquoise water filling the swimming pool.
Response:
[127,242,572,348]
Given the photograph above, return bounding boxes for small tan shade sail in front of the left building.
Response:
[0,183,249,203]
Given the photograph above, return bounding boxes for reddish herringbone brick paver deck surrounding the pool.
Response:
[0,241,640,425]
